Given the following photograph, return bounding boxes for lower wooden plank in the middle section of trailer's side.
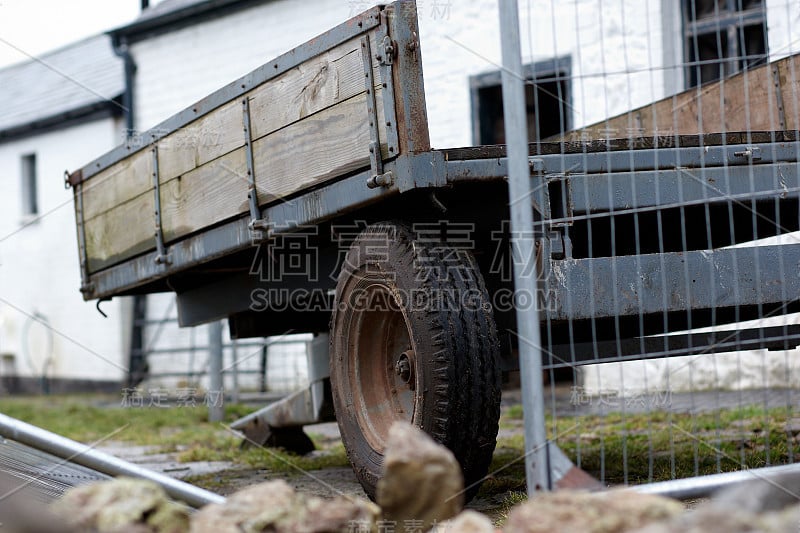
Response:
[161,147,249,242]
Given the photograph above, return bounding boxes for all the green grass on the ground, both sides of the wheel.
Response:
[0,396,800,502]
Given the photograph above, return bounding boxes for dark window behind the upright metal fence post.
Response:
[470,57,572,145]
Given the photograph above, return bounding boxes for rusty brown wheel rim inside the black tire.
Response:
[347,283,419,450]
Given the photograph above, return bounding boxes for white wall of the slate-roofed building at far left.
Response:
[0,118,130,380]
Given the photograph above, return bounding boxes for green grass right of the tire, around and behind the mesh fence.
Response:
[481,406,800,495]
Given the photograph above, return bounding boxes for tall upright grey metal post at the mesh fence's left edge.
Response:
[500,0,551,496]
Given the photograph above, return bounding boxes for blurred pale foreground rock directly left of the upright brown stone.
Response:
[191,480,379,533]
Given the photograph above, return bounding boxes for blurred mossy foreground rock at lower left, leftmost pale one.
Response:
[52,477,189,533]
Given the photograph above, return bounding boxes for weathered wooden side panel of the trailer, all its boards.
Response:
[82,32,390,272]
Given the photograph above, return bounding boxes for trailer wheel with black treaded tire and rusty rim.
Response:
[330,222,501,501]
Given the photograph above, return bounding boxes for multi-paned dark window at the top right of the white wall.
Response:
[683,0,769,87]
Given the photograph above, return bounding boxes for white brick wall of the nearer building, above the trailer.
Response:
[132,0,665,147]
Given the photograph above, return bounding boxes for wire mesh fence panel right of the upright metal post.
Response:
[494,0,800,485]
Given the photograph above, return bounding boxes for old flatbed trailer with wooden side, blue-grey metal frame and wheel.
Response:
[67,2,800,495]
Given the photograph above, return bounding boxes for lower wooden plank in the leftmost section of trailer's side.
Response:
[85,191,155,272]
